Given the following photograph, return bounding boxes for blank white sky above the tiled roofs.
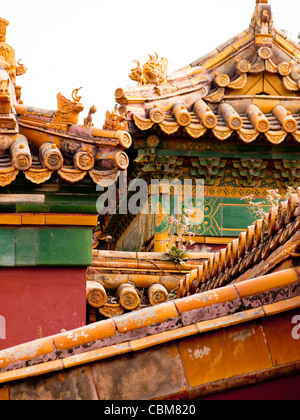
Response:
[0,0,300,127]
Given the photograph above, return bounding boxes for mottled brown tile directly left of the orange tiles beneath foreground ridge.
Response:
[92,345,187,400]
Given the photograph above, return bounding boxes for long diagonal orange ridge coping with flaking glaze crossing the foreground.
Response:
[0,262,300,383]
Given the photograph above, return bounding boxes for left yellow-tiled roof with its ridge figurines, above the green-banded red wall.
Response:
[0,19,132,187]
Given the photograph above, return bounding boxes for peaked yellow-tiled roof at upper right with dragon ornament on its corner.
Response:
[115,2,300,144]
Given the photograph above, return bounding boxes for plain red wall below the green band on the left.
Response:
[0,267,86,350]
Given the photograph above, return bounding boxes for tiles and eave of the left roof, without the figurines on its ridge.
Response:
[0,105,131,187]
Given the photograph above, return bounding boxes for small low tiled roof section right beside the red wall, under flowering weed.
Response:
[87,250,211,322]
